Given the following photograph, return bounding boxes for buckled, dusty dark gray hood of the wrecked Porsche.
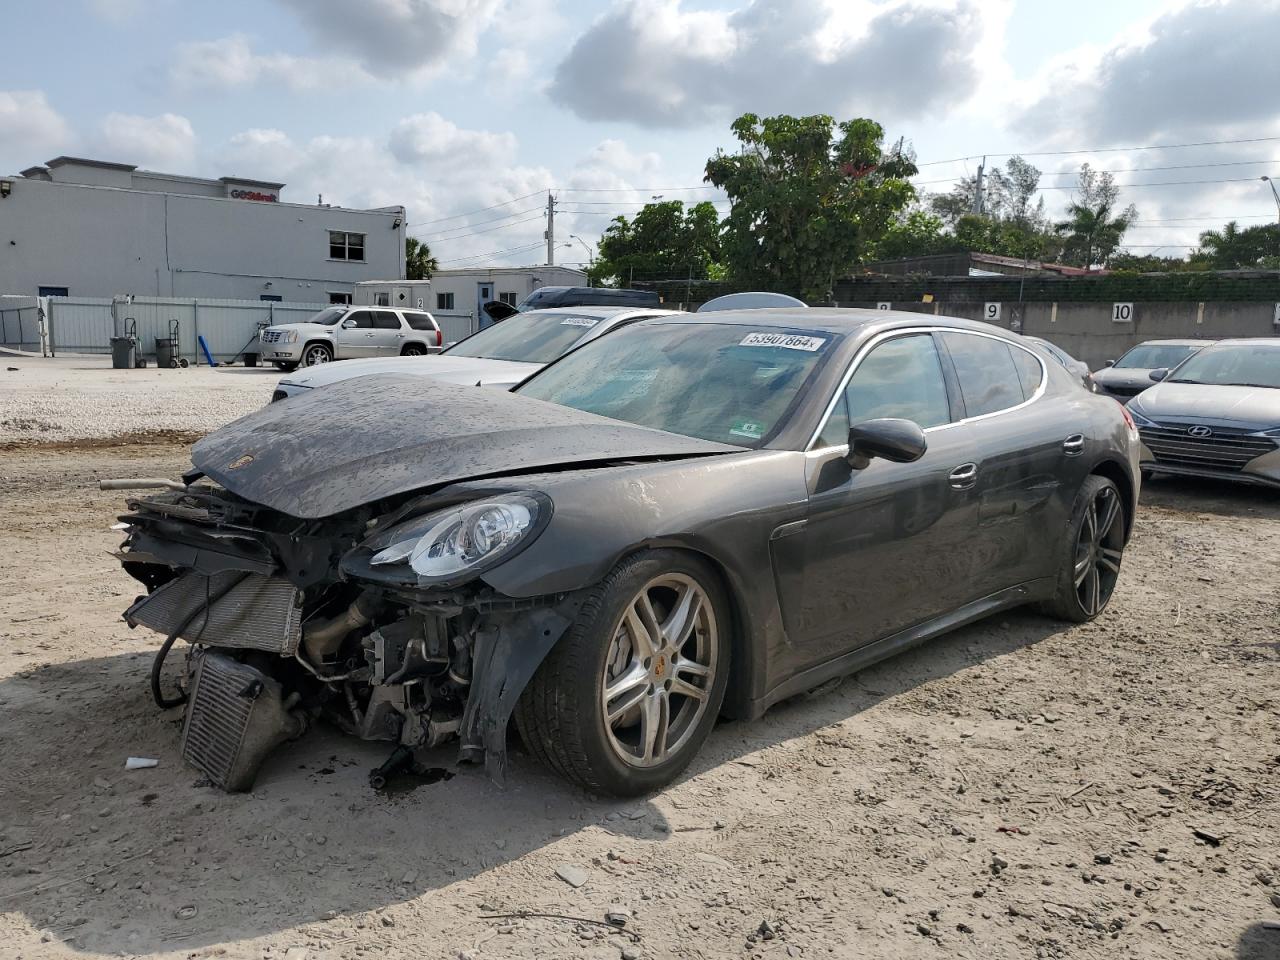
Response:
[191,378,742,518]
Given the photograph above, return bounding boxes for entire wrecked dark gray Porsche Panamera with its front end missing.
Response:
[110,310,1138,795]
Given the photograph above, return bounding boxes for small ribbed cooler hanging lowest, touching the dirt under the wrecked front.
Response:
[182,653,306,791]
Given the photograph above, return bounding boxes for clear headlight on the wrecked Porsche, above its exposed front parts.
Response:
[367,493,552,584]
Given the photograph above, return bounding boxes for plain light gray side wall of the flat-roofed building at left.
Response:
[0,177,404,303]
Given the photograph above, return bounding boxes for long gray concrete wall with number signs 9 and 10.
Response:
[841,301,1280,370]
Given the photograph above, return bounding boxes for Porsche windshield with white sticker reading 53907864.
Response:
[517,323,837,447]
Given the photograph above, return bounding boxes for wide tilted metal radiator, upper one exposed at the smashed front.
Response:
[124,571,302,657]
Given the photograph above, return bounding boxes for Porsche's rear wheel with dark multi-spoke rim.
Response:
[1041,475,1126,623]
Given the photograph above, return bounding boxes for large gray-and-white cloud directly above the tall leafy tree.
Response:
[549,0,988,127]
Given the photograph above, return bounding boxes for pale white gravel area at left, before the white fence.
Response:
[0,356,280,448]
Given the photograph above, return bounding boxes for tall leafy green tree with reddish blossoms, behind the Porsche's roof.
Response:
[705,114,916,301]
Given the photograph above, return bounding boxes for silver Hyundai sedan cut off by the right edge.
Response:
[1129,339,1280,488]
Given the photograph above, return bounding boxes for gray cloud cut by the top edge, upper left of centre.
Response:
[280,0,500,79]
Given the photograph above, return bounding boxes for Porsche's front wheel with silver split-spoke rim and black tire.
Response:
[516,550,731,796]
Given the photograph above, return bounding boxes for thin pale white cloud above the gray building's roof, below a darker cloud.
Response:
[169,33,371,91]
